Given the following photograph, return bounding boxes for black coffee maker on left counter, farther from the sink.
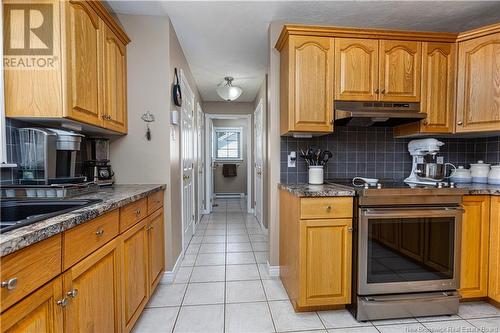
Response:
[83,138,115,186]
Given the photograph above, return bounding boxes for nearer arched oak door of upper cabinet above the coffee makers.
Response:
[66,1,103,126]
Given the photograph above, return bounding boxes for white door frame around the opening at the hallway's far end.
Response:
[205,113,254,214]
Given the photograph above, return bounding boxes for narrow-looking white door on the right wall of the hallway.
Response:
[254,100,264,224]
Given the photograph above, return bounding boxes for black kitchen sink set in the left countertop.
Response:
[0,199,102,233]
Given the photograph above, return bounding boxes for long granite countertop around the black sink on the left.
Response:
[0,184,165,257]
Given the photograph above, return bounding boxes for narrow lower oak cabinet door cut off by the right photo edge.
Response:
[488,196,500,302]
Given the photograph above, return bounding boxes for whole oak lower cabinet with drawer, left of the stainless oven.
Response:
[280,190,352,311]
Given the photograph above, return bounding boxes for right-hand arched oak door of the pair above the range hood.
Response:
[379,40,422,102]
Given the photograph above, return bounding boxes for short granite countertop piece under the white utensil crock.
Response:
[278,183,356,197]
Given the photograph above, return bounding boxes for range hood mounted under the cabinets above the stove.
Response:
[334,101,427,127]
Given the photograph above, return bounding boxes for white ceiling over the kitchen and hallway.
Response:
[108,1,500,102]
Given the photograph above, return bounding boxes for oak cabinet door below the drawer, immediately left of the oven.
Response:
[299,219,352,306]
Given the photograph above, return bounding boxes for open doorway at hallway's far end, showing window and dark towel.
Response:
[205,114,254,213]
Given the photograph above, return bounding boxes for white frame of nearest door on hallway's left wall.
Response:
[179,68,196,254]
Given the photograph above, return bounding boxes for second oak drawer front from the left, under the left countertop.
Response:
[63,209,119,270]
